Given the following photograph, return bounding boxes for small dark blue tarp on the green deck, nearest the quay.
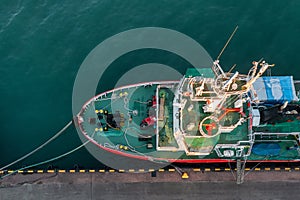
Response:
[252,143,280,156]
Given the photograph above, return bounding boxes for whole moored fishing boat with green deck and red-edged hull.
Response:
[77,60,300,163]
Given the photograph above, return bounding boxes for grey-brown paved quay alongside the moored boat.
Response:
[0,170,300,200]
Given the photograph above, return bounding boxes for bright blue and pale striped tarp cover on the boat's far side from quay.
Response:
[253,76,298,103]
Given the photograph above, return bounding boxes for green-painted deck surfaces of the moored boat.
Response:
[81,76,300,161]
